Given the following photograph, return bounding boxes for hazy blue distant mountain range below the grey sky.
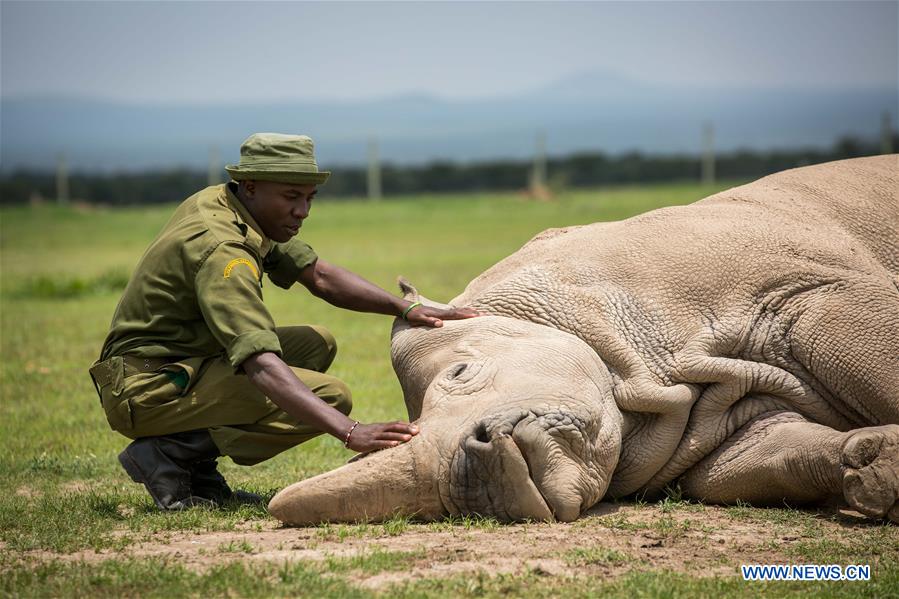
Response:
[0,71,899,172]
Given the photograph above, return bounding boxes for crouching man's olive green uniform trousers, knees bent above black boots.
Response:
[91,326,352,465]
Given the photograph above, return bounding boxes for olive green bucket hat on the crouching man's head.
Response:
[225,133,331,185]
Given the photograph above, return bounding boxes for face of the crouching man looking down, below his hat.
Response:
[244,181,316,243]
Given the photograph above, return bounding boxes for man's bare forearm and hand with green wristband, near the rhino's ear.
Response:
[300,258,478,327]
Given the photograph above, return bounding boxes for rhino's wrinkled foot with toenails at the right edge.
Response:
[841,424,899,523]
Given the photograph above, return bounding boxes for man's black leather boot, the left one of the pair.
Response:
[119,431,219,510]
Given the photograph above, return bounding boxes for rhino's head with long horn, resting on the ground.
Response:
[269,286,621,525]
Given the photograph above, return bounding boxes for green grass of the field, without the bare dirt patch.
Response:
[0,184,899,597]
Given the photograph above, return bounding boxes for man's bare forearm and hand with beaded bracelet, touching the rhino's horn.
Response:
[241,352,418,452]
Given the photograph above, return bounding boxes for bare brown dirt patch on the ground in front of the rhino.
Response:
[14,504,899,588]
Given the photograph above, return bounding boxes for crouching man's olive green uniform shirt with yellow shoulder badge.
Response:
[101,185,317,367]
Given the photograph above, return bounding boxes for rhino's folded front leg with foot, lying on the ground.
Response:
[680,412,899,522]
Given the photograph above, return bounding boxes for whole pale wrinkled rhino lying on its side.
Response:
[269,155,899,525]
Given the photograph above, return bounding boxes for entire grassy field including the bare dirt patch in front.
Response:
[0,184,899,597]
